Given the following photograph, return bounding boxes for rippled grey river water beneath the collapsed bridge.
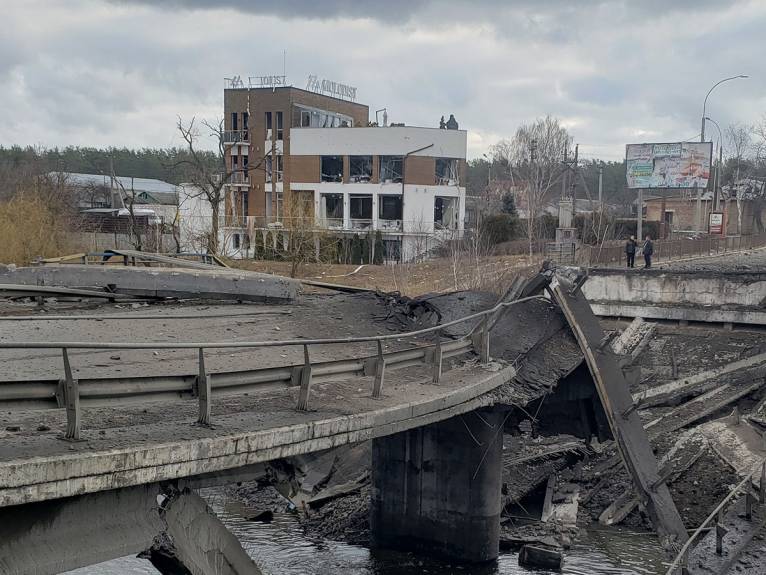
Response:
[67,490,664,575]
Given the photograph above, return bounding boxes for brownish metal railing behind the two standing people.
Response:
[577,234,766,267]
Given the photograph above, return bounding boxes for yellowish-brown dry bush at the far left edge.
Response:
[0,194,83,265]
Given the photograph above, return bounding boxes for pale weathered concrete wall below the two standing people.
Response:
[582,270,766,308]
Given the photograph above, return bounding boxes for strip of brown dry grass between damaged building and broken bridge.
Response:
[227,256,542,296]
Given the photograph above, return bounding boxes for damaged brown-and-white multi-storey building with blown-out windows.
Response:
[221,81,467,260]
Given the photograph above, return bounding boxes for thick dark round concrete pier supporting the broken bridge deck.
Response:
[370,410,503,562]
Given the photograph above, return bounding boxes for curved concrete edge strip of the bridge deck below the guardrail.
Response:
[0,364,514,506]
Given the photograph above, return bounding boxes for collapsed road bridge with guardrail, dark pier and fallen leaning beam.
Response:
[0,264,744,572]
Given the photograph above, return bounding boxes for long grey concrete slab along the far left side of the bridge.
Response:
[0,264,300,302]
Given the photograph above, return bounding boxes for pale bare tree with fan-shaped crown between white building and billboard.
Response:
[491,116,572,256]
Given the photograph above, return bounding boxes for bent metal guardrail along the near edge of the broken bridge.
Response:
[0,295,545,440]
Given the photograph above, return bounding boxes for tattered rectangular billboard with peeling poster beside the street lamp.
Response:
[625,142,713,189]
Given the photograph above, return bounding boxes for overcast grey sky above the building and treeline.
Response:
[0,0,766,160]
